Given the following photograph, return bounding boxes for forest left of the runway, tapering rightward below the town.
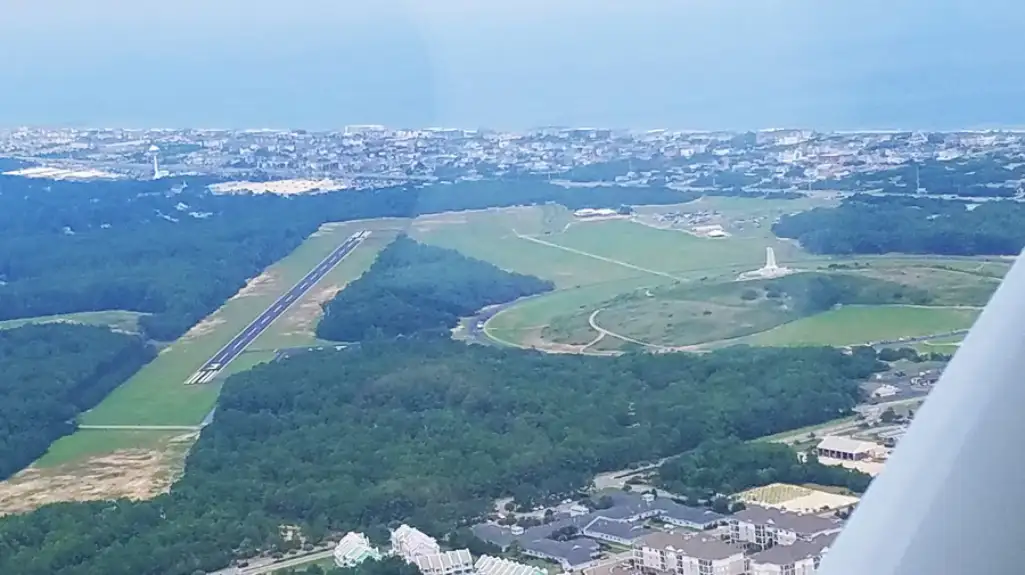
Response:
[0,175,696,340]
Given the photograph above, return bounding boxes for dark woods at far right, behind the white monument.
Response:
[773,195,1025,255]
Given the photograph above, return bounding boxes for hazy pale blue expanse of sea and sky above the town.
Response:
[0,0,1025,129]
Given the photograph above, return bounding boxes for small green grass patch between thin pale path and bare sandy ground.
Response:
[33,429,188,467]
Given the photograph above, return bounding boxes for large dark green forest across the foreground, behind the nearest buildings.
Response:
[0,338,880,575]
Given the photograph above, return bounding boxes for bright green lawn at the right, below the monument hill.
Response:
[744,305,979,345]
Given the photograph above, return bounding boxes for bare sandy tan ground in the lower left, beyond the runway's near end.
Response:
[0,433,199,516]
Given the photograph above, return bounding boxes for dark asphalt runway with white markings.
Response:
[186,230,370,384]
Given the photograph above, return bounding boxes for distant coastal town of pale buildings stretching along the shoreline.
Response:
[0,126,1025,197]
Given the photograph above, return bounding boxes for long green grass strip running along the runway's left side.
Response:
[80,220,401,425]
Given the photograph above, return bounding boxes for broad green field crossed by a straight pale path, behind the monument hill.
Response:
[410,198,844,346]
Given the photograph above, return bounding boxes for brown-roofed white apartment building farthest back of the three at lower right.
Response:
[730,503,844,549]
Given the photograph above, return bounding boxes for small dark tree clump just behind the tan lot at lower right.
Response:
[658,438,872,502]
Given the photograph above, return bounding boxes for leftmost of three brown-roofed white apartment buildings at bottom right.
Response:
[633,532,748,575]
